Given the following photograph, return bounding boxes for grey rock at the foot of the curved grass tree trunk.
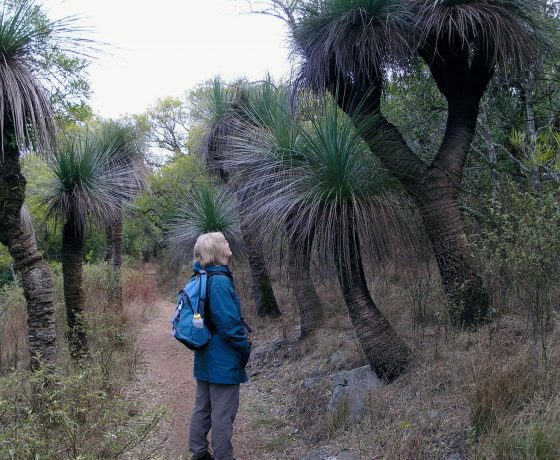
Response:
[327,366,381,422]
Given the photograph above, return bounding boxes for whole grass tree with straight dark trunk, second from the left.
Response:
[45,132,138,359]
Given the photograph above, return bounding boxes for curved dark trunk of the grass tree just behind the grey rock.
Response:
[337,221,412,381]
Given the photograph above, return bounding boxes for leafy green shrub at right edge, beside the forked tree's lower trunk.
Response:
[474,184,560,357]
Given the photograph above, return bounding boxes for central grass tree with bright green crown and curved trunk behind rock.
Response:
[231,102,411,380]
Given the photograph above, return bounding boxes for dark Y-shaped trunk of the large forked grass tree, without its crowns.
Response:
[330,48,492,326]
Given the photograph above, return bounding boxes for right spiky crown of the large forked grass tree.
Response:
[411,0,546,71]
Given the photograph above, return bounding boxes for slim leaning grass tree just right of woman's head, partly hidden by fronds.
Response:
[199,79,280,317]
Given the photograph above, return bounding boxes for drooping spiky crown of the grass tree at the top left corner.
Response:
[0,0,88,150]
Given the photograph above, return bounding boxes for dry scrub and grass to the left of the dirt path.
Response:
[0,264,165,460]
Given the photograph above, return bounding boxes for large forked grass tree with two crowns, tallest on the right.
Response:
[286,0,541,325]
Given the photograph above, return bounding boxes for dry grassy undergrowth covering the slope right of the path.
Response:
[235,260,560,459]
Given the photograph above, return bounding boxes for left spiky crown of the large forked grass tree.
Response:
[292,0,412,88]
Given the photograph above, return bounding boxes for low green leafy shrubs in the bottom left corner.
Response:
[0,365,165,460]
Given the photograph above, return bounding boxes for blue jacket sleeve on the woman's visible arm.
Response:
[210,277,250,353]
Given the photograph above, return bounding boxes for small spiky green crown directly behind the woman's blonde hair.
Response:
[167,183,239,261]
